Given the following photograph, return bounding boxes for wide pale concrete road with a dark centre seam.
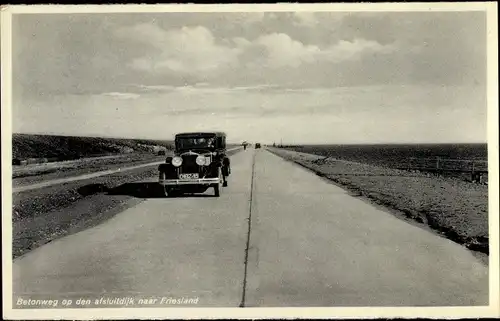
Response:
[13,149,488,307]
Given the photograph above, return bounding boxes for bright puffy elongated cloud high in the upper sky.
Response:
[117,24,391,78]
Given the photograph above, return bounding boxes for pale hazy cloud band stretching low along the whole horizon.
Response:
[13,86,486,143]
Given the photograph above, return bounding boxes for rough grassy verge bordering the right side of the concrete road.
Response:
[270,148,489,254]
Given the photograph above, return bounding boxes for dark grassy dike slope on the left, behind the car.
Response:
[12,134,172,165]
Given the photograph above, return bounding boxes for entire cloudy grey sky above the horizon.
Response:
[12,12,487,144]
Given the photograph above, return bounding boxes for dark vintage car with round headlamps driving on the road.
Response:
[158,132,231,197]
